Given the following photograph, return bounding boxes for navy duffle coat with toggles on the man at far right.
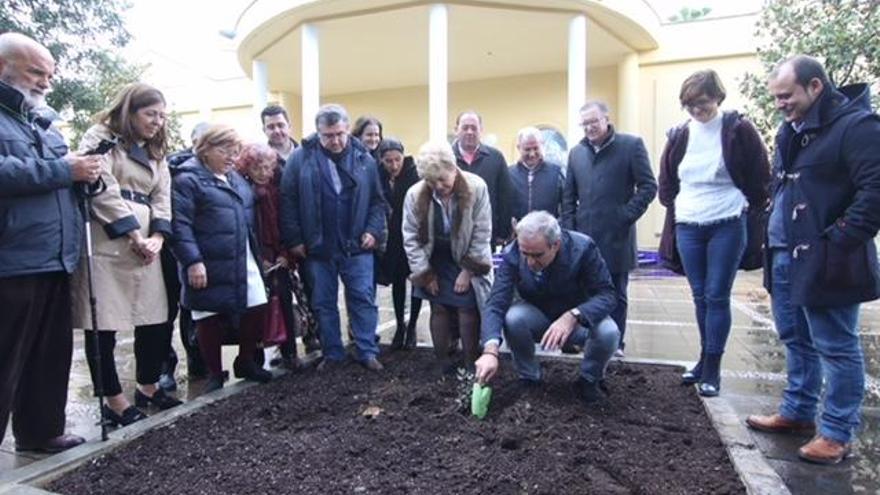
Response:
[764,84,880,306]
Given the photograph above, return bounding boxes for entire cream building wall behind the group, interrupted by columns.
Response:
[174,56,760,252]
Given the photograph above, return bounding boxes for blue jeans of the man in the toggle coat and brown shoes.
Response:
[771,249,865,443]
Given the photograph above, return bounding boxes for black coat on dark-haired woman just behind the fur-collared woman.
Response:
[379,156,419,284]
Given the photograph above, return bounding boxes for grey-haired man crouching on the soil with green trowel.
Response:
[475,211,620,403]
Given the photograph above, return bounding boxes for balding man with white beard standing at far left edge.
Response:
[0,33,100,452]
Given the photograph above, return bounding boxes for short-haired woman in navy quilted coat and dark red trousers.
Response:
[172,125,272,392]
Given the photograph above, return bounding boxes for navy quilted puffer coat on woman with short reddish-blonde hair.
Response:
[171,157,259,314]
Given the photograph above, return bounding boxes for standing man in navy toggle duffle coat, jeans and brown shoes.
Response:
[747,55,880,464]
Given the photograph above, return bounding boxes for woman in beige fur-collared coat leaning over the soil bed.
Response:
[402,143,492,372]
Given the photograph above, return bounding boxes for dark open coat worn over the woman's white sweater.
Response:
[658,111,770,273]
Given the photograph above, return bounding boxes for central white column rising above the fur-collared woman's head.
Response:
[428,3,449,141]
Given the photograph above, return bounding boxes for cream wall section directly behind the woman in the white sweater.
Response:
[637,56,761,248]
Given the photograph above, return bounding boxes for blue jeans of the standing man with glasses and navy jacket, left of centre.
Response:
[305,253,379,361]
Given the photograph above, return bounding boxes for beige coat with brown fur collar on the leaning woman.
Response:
[401,171,493,312]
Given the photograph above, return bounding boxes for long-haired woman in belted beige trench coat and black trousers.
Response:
[72,83,180,426]
